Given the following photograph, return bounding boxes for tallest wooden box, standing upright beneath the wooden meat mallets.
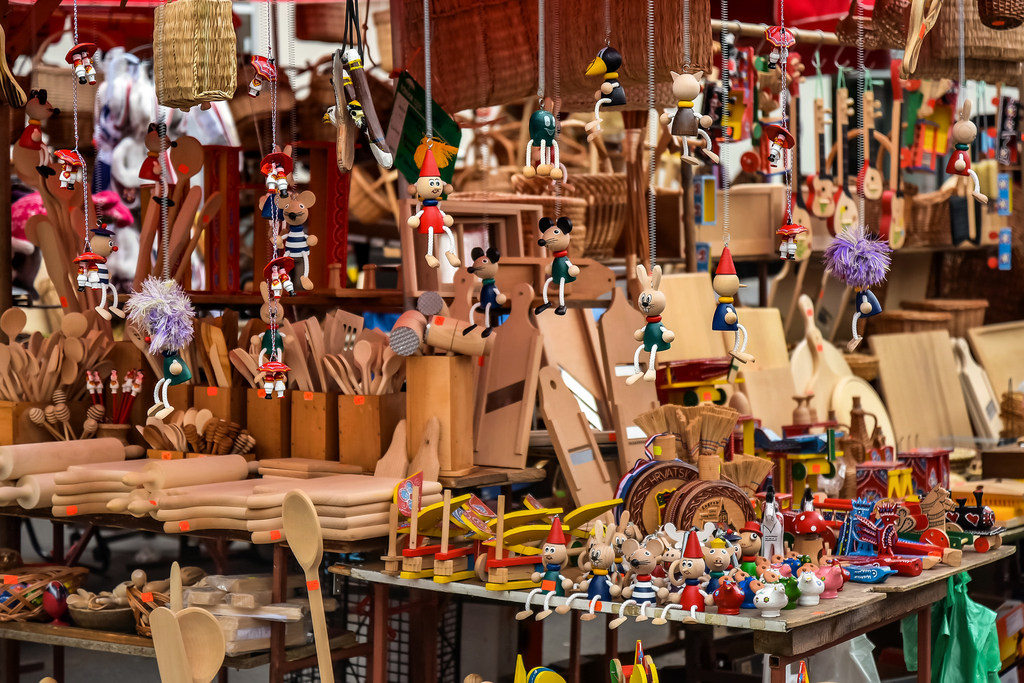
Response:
[406,355,473,476]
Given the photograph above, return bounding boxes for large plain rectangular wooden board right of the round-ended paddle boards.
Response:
[868,331,973,447]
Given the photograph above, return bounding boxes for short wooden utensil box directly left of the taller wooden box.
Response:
[338,393,406,472]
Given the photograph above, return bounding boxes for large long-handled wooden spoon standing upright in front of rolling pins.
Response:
[281,489,334,683]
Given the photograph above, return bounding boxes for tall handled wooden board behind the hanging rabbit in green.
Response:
[597,288,659,472]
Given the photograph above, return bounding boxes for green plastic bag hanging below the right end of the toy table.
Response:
[900,571,1000,683]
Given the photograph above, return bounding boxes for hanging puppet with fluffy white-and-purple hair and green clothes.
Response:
[126,275,196,419]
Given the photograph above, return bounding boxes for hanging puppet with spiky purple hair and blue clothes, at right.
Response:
[825,231,892,351]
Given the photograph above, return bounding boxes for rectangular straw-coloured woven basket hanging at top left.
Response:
[153,0,237,110]
